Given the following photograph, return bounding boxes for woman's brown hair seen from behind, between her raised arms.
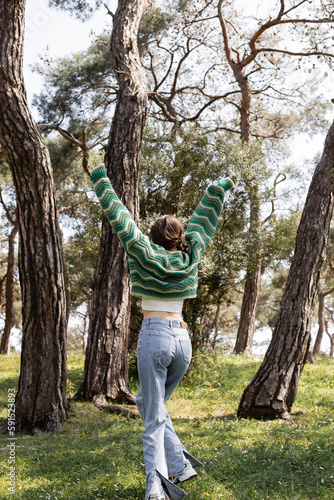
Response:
[149,215,188,252]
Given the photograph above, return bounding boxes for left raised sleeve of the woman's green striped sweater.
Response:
[91,164,144,253]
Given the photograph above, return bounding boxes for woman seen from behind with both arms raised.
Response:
[91,165,233,500]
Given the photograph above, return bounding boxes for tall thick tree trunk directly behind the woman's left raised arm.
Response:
[75,0,152,403]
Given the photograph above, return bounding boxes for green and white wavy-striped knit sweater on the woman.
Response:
[91,165,233,300]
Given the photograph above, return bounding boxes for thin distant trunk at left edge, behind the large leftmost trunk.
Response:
[0,223,18,354]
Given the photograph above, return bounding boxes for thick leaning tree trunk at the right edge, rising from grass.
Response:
[238,122,334,418]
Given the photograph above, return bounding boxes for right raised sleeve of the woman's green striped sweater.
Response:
[185,178,233,258]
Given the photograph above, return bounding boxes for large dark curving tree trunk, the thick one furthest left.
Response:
[0,0,69,433]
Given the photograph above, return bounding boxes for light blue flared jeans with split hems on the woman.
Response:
[136,318,202,500]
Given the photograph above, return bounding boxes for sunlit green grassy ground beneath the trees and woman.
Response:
[0,355,334,500]
